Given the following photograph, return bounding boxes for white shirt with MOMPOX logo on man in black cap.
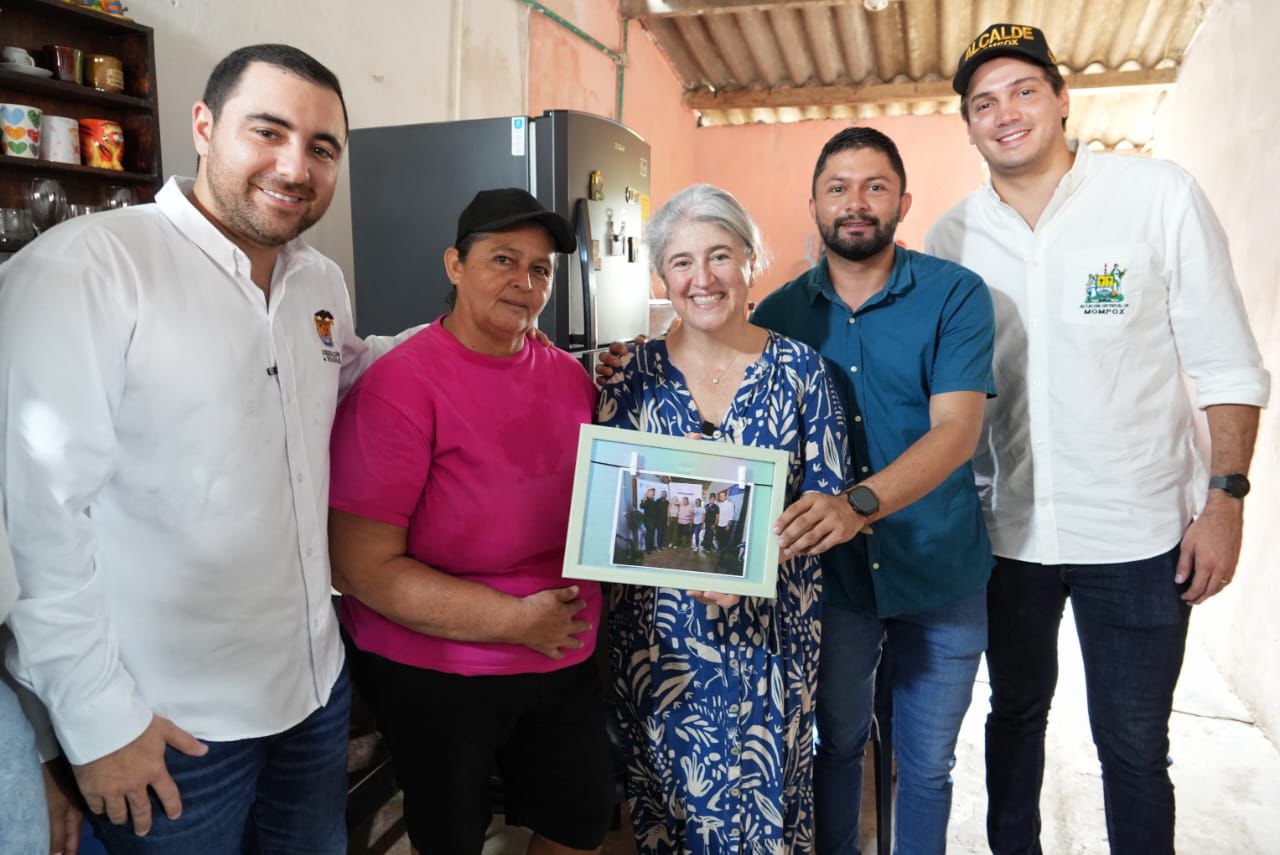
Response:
[925,142,1270,564]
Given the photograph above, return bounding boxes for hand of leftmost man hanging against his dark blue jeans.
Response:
[72,715,209,837]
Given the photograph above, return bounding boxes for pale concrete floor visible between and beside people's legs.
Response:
[349,605,1280,855]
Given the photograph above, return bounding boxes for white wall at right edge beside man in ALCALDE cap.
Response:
[1156,0,1280,741]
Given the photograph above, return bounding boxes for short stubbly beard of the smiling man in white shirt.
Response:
[206,152,329,247]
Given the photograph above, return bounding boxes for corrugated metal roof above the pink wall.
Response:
[621,0,1216,151]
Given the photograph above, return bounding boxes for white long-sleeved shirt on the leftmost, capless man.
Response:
[0,179,404,763]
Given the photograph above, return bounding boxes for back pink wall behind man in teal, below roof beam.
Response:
[696,115,984,300]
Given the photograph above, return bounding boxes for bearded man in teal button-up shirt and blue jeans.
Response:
[753,128,995,852]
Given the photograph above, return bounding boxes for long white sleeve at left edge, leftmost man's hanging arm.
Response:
[0,247,151,764]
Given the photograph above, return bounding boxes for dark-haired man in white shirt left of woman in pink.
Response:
[0,45,399,855]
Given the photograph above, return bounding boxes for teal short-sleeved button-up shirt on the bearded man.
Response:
[751,247,996,617]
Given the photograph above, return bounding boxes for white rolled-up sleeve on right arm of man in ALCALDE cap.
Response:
[1165,177,1271,410]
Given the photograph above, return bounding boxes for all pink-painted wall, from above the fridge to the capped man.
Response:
[519,9,983,300]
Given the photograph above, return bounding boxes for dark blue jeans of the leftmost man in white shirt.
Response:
[92,667,351,855]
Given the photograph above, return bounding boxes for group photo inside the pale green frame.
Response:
[612,470,751,579]
